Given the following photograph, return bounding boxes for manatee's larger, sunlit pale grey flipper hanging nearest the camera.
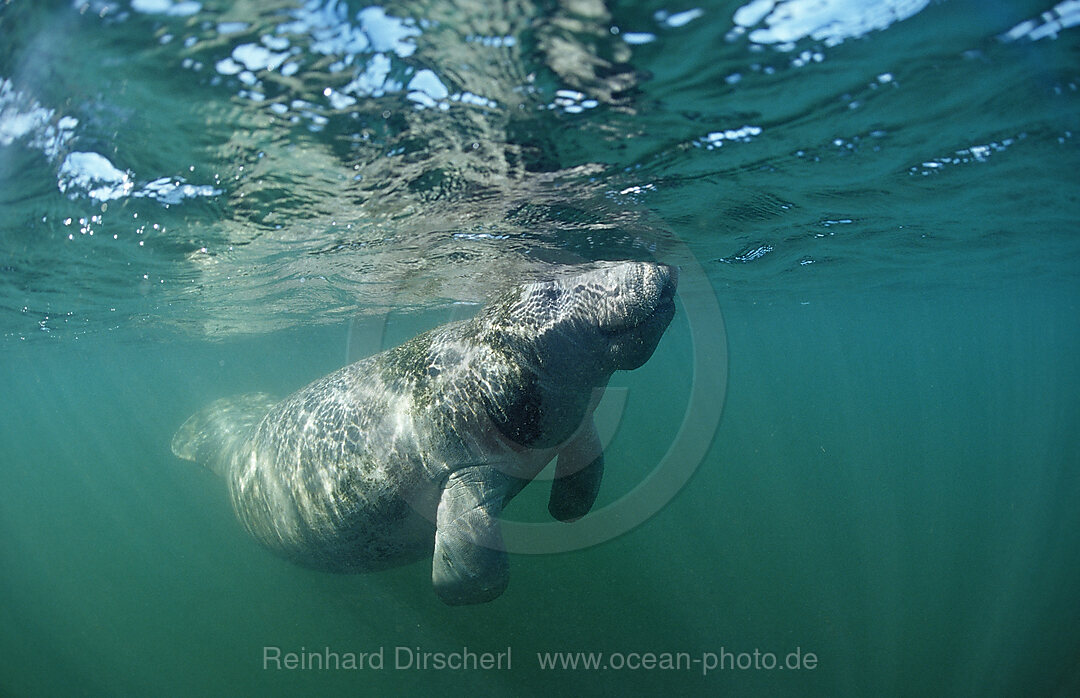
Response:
[431,466,512,606]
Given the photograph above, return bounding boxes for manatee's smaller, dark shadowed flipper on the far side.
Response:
[548,417,604,522]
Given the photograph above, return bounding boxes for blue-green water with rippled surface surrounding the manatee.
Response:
[0,2,1080,696]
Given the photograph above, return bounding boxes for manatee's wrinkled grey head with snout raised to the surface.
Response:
[476,261,678,446]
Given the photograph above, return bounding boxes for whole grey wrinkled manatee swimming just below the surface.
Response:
[173,263,677,604]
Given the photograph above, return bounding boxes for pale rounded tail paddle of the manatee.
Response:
[173,392,278,475]
